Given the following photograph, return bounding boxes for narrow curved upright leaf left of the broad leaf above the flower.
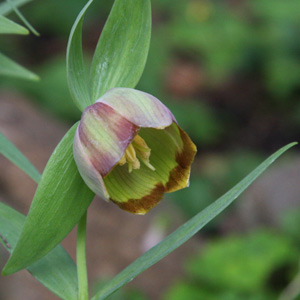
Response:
[67,0,93,111]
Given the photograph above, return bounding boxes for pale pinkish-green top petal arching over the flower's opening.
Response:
[96,88,176,128]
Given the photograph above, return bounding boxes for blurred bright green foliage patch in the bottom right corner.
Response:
[164,230,298,300]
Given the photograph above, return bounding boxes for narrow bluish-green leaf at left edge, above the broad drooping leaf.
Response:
[0,132,41,183]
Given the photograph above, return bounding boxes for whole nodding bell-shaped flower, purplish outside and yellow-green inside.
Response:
[73,88,196,214]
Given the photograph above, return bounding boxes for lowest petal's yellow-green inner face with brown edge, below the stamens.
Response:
[104,164,165,215]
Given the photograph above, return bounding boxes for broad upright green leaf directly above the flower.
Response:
[90,0,151,104]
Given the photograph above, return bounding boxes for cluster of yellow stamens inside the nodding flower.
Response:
[118,135,155,173]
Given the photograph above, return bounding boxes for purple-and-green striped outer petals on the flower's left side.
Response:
[73,103,139,198]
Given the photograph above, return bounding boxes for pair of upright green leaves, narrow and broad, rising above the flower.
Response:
[67,0,151,111]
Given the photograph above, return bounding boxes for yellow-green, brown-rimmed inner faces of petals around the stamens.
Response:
[104,123,196,214]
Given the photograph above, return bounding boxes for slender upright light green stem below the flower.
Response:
[77,212,89,300]
